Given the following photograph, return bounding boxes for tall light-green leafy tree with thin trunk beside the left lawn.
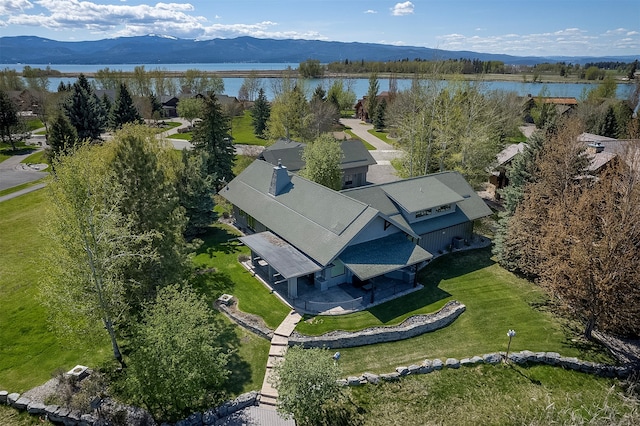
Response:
[41,146,156,365]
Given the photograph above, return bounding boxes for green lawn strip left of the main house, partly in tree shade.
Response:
[194,224,290,329]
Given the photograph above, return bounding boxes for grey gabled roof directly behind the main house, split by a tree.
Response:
[260,139,376,172]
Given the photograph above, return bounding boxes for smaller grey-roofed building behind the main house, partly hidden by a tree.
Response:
[258,139,376,189]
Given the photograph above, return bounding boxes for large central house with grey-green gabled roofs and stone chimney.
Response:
[219,160,491,298]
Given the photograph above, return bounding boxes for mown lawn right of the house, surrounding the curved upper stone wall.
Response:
[310,249,613,374]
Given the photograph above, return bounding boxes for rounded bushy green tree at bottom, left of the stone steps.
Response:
[127,286,230,422]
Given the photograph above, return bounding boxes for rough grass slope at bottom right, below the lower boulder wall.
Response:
[352,365,640,426]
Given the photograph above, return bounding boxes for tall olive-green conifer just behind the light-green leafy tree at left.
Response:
[110,125,189,305]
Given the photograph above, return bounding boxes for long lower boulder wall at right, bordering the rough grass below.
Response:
[338,350,634,386]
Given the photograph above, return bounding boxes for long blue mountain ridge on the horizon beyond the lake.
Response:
[0,35,636,65]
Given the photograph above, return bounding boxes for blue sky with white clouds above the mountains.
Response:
[0,0,640,56]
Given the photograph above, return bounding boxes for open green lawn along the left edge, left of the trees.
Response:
[0,190,109,392]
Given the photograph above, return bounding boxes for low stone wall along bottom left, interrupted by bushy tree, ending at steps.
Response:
[0,390,259,426]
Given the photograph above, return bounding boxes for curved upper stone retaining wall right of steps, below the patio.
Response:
[289,300,466,349]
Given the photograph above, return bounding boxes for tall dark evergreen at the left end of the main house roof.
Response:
[191,94,235,187]
